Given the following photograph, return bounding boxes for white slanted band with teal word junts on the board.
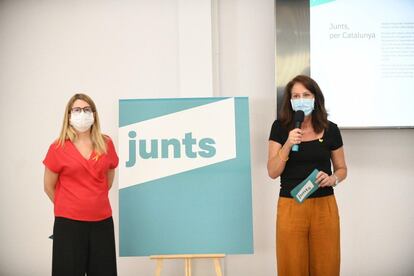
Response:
[118,98,236,189]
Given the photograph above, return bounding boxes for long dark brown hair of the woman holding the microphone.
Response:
[279,75,329,133]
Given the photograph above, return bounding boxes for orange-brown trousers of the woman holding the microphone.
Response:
[276,195,340,276]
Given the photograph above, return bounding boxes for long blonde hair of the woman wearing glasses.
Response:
[57,93,107,156]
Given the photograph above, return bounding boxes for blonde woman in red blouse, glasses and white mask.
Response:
[43,94,118,276]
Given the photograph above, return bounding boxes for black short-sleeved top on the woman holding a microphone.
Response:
[269,120,343,197]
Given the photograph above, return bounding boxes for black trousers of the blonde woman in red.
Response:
[52,217,117,276]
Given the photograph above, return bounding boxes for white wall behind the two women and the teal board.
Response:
[0,0,414,276]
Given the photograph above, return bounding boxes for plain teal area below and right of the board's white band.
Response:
[119,97,253,256]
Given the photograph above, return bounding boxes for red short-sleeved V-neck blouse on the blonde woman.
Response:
[43,137,118,221]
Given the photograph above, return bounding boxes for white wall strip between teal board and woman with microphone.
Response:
[219,0,279,276]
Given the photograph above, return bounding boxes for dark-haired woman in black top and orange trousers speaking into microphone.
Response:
[267,75,347,276]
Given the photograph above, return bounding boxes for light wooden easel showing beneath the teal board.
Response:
[150,254,225,276]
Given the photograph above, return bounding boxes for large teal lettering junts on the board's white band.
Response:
[125,130,216,168]
